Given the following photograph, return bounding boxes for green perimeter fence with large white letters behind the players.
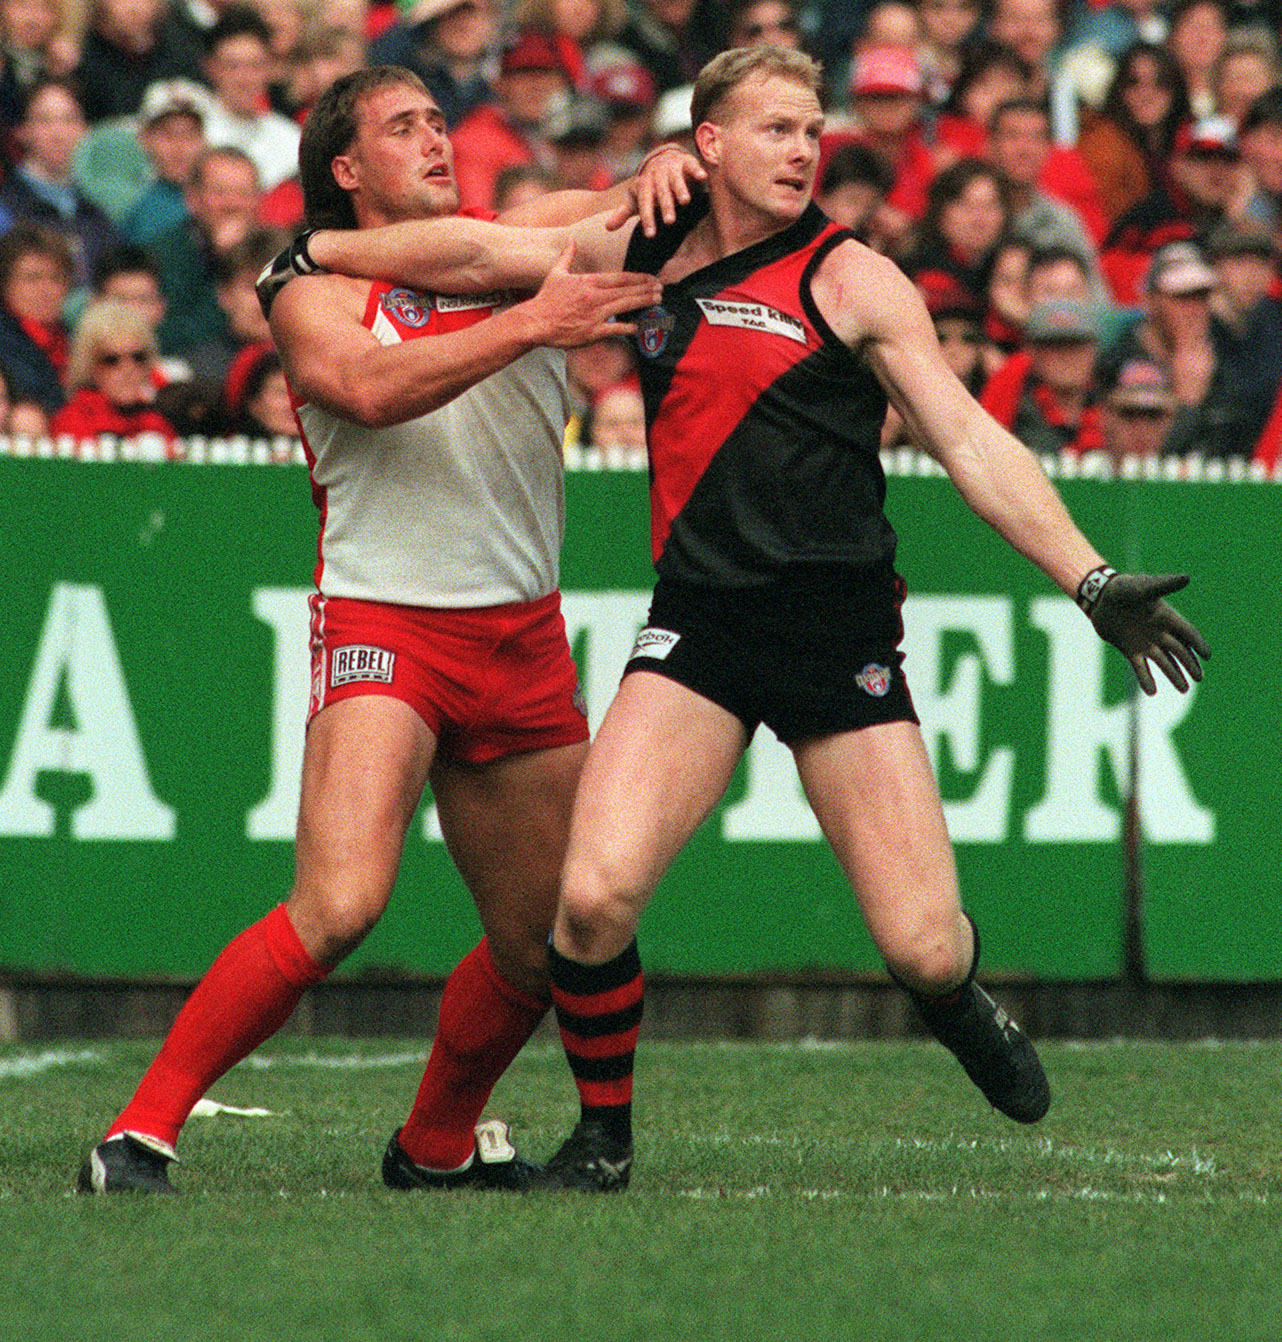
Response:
[0,454,1282,980]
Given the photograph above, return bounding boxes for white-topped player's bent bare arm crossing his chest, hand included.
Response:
[271,247,659,427]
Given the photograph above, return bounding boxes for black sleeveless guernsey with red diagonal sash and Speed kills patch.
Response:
[626,201,895,601]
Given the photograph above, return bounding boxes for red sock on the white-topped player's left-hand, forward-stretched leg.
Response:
[107,905,329,1146]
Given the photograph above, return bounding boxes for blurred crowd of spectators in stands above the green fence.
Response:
[0,0,1282,467]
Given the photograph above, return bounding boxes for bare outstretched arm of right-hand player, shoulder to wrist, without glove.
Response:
[813,243,1103,597]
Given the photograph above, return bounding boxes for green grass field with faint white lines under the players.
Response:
[0,1039,1282,1342]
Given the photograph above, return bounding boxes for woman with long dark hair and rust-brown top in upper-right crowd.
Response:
[1078,42,1189,224]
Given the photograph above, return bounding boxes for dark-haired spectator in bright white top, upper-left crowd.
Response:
[205,5,308,191]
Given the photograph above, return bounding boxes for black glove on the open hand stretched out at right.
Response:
[1077,568,1211,694]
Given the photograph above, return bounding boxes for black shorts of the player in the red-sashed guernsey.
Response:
[623,581,918,745]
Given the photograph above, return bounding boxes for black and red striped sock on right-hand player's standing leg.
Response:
[548,939,644,1142]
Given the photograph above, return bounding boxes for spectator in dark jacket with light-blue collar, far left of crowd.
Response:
[0,79,119,285]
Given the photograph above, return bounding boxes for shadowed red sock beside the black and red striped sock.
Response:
[399,937,550,1170]
